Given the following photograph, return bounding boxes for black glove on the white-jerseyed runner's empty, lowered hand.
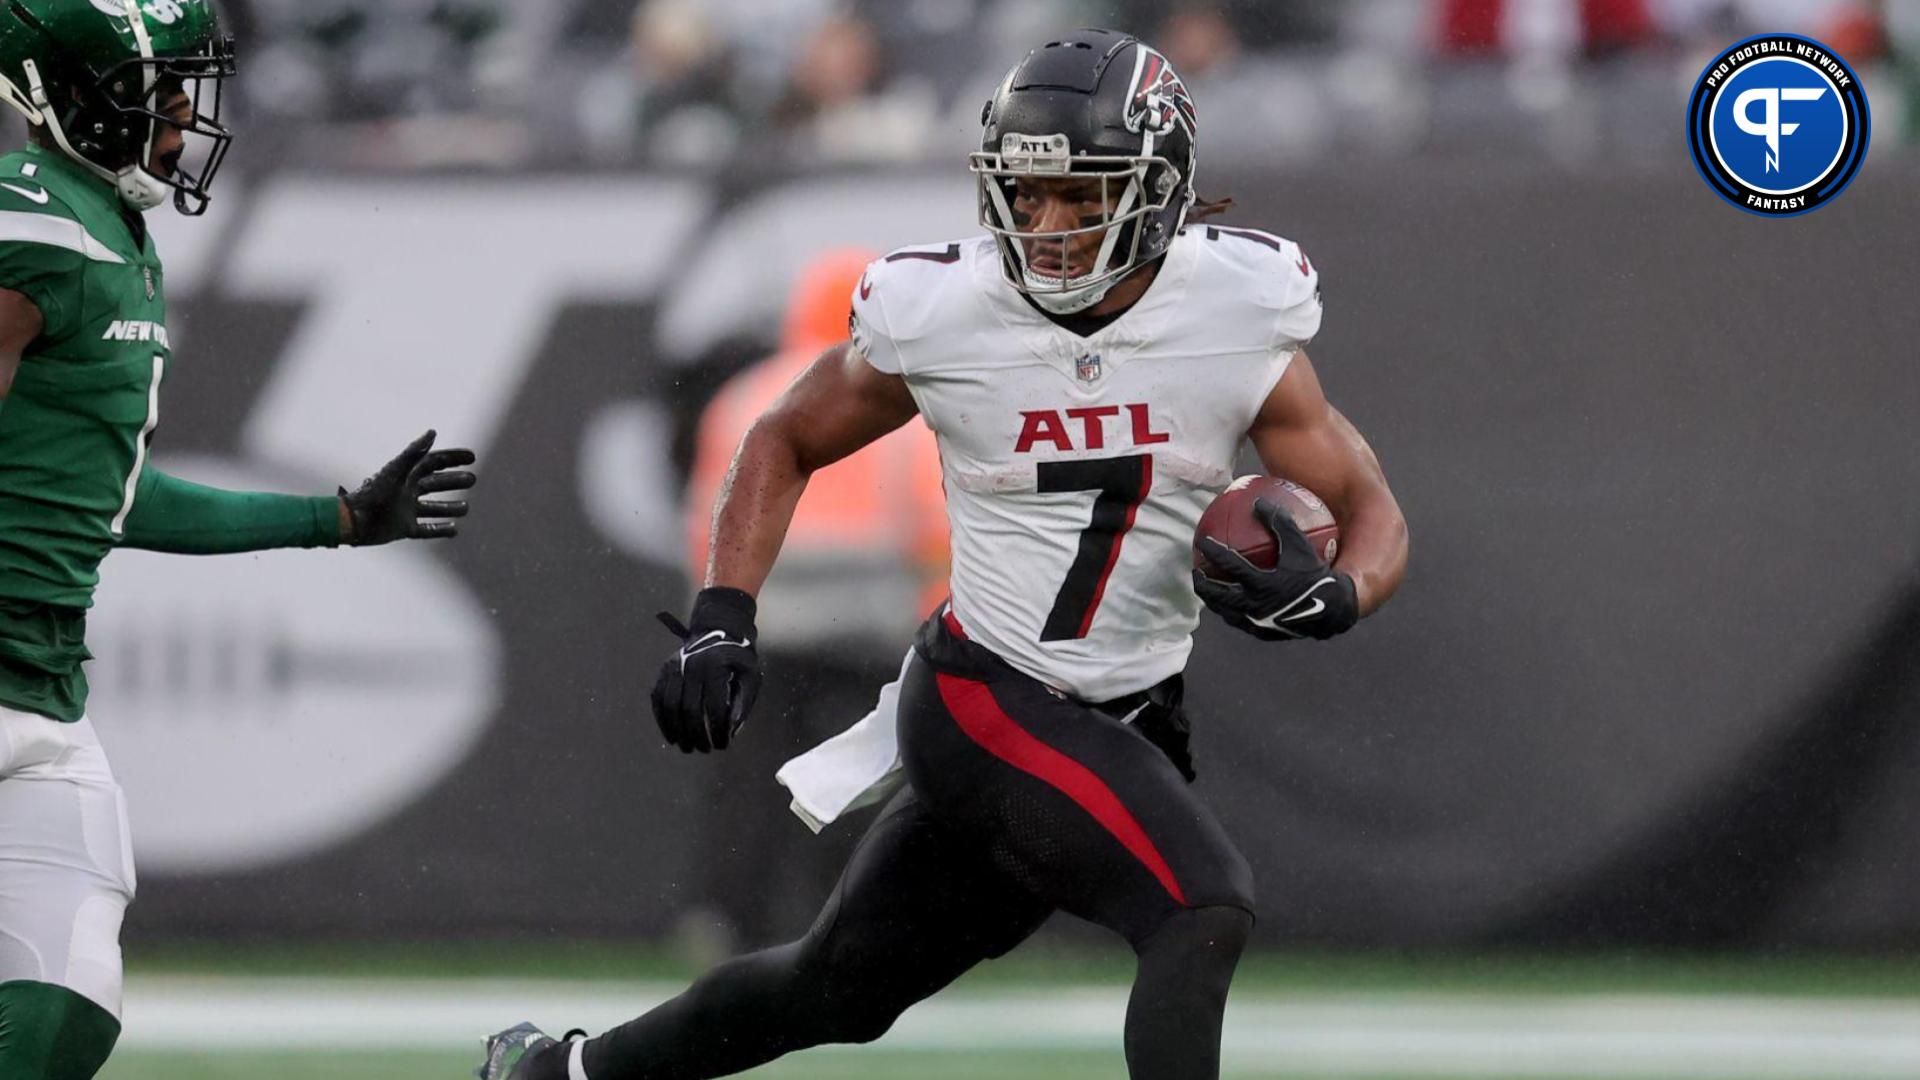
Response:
[653,588,760,753]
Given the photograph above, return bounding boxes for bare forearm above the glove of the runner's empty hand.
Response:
[701,413,810,596]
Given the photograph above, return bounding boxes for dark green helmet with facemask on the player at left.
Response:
[0,0,234,215]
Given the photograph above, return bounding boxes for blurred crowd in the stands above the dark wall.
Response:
[225,0,1920,169]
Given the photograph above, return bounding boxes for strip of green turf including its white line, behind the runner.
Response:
[102,944,1920,1080]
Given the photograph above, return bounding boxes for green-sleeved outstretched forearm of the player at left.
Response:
[121,467,342,555]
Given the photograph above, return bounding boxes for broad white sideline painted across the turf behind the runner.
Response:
[121,976,1920,1080]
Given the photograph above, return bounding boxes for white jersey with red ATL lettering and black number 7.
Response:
[852,225,1321,701]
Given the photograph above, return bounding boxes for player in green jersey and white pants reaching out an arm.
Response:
[0,0,474,1080]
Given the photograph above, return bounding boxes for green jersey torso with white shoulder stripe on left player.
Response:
[0,148,171,719]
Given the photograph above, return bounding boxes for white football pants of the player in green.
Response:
[0,707,134,1019]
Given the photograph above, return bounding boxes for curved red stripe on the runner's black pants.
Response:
[933,673,1187,907]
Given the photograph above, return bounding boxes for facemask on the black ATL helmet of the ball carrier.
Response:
[968,133,1185,315]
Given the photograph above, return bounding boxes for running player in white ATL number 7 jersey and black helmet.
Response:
[480,31,1407,1080]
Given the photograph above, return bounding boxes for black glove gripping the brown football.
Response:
[1194,500,1359,642]
